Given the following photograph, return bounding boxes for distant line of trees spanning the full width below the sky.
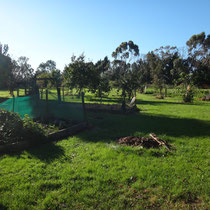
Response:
[0,32,210,101]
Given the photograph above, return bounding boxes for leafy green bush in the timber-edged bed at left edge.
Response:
[0,109,45,144]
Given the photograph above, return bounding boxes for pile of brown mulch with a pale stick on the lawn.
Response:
[117,133,171,151]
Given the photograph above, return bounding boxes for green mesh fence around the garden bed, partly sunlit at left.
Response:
[0,91,84,121]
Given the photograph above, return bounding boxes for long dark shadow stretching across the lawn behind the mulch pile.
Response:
[78,112,210,142]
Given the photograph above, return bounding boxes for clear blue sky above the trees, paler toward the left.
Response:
[0,0,210,70]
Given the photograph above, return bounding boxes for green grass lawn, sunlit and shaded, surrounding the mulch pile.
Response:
[0,89,210,209]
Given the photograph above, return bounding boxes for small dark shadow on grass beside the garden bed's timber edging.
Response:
[27,143,64,163]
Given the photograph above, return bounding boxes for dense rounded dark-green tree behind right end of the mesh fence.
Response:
[64,54,94,96]
